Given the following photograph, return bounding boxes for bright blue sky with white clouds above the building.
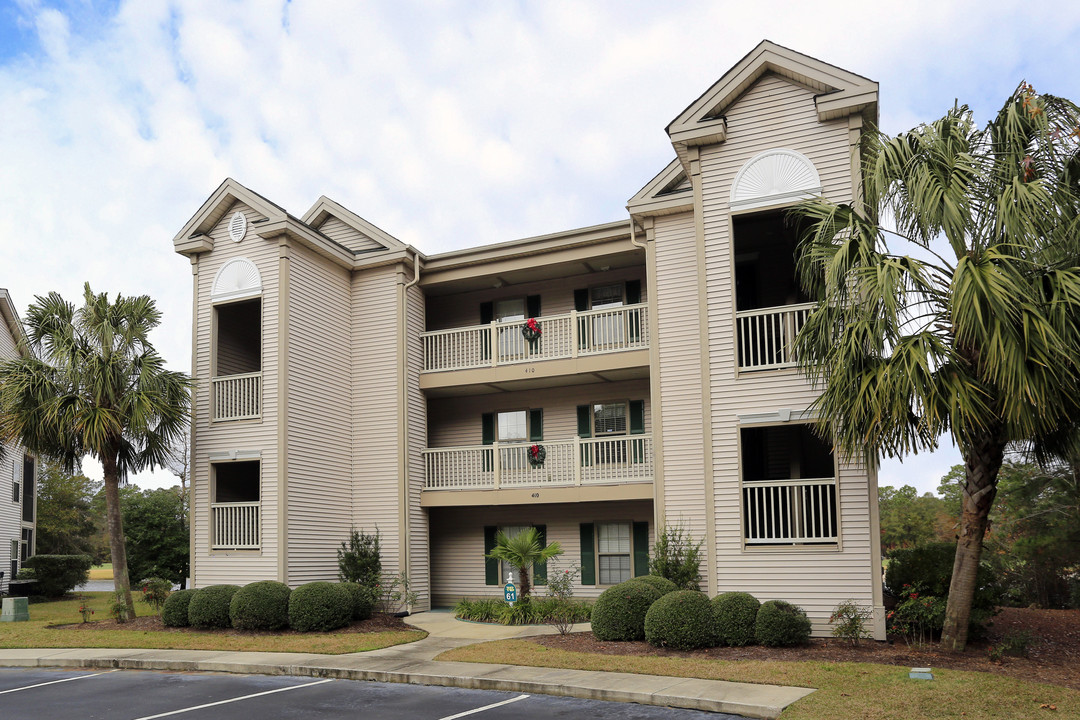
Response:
[0,0,1080,490]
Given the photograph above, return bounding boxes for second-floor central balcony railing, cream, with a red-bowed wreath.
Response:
[423,435,653,490]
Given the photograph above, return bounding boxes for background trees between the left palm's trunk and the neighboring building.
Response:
[37,462,98,557]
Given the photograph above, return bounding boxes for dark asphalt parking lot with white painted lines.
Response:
[0,668,741,720]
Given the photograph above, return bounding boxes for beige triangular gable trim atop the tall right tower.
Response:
[667,40,878,158]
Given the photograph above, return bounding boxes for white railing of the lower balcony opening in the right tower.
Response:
[743,477,839,545]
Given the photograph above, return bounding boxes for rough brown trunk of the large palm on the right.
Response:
[942,437,1005,652]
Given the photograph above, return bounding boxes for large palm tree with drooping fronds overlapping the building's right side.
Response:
[794,83,1080,650]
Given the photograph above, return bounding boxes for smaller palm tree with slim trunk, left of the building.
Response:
[0,284,191,619]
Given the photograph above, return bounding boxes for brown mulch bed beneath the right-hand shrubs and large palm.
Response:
[521,608,1080,690]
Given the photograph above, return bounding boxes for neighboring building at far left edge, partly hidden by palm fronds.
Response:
[0,287,38,590]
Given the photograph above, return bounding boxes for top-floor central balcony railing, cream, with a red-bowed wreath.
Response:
[420,304,649,372]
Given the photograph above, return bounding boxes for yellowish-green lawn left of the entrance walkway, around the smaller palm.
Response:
[0,593,427,655]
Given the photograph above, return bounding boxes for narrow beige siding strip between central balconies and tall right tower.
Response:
[653,213,705,538]
